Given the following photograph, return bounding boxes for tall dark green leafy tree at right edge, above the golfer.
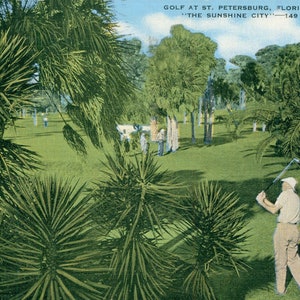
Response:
[258,44,300,157]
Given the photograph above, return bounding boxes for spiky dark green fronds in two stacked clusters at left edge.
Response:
[0,32,39,200]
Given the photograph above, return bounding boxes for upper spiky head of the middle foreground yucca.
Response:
[95,154,182,236]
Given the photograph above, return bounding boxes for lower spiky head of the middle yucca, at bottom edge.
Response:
[107,239,174,300]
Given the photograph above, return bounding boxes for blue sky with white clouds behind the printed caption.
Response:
[112,0,300,66]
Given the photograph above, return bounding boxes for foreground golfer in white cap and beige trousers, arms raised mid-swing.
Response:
[256,177,300,295]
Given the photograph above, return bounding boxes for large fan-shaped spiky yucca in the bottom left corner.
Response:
[0,177,107,300]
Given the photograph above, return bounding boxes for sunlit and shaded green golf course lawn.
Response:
[5,115,300,300]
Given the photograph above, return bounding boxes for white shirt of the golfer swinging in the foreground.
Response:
[275,189,300,224]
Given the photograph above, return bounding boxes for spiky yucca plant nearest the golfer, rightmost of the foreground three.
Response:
[173,181,247,299]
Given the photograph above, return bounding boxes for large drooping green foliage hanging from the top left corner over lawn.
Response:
[0,0,131,153]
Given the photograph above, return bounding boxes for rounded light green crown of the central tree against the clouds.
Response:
[146,25,216,144]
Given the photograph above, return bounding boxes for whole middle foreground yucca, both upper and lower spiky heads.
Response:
[91,154,182,300]
